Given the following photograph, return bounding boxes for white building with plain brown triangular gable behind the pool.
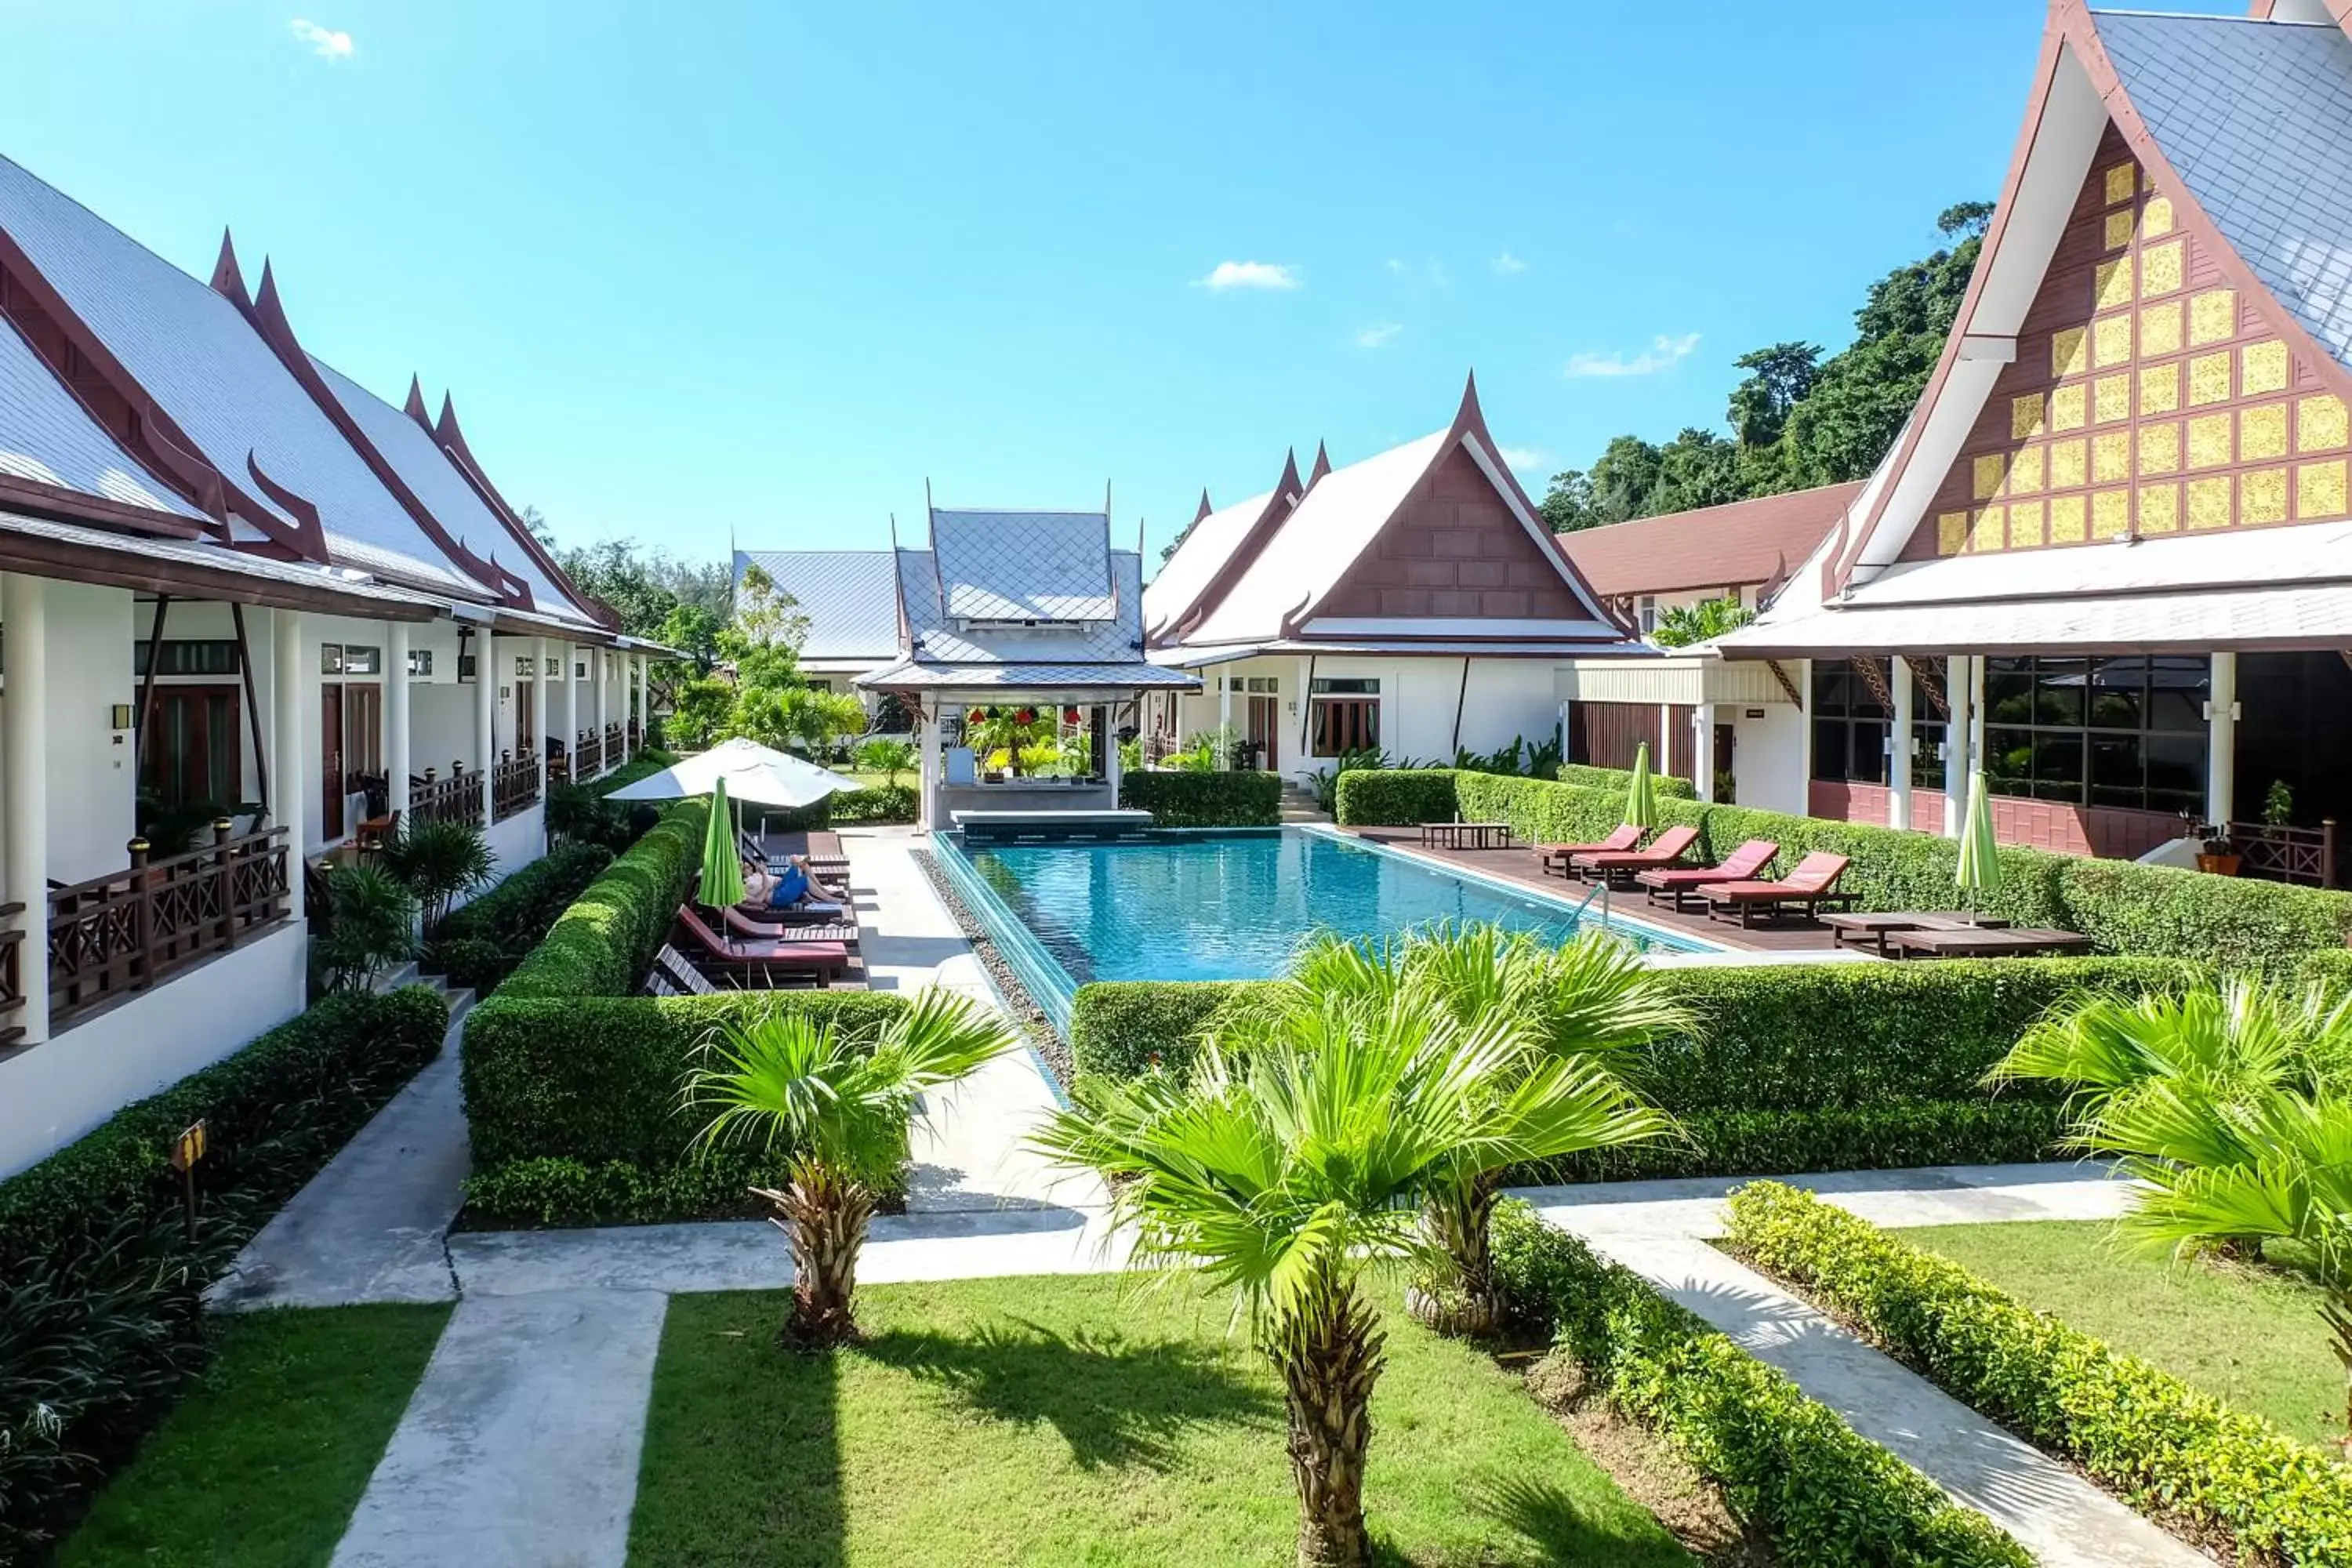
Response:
[1143,381,1649,779]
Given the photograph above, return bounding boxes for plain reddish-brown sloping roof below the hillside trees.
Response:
[1559,480,1863,600]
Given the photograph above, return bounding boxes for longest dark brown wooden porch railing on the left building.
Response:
[49,822,287,1027]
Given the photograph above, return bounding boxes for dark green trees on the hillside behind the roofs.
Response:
[1543,202,1992,534]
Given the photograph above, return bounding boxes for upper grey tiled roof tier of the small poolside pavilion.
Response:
[931,508,1112,621]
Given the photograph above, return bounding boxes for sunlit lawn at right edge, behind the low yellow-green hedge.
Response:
[1900,1220,2345,1443]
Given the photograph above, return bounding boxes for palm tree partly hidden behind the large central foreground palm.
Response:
[1270,924,1691,1333]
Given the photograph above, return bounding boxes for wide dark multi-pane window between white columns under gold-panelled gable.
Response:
[1985,656,2211,811]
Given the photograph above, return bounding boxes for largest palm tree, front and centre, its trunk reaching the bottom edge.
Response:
[1037,989,1665,1568]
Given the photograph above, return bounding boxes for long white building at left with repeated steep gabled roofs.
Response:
[0,160,654,1173]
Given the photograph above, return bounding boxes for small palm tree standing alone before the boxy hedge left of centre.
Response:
[684,989,1016,1349]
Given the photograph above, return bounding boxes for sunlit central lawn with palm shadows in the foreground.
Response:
[630,1276,1691,1568]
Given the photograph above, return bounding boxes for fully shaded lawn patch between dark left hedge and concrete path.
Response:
[56,1307,449,1568]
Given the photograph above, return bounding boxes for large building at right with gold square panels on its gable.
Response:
[1719,0,2352,881]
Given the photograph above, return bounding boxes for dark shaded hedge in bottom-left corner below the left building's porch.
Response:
[0,987,449,1561]
